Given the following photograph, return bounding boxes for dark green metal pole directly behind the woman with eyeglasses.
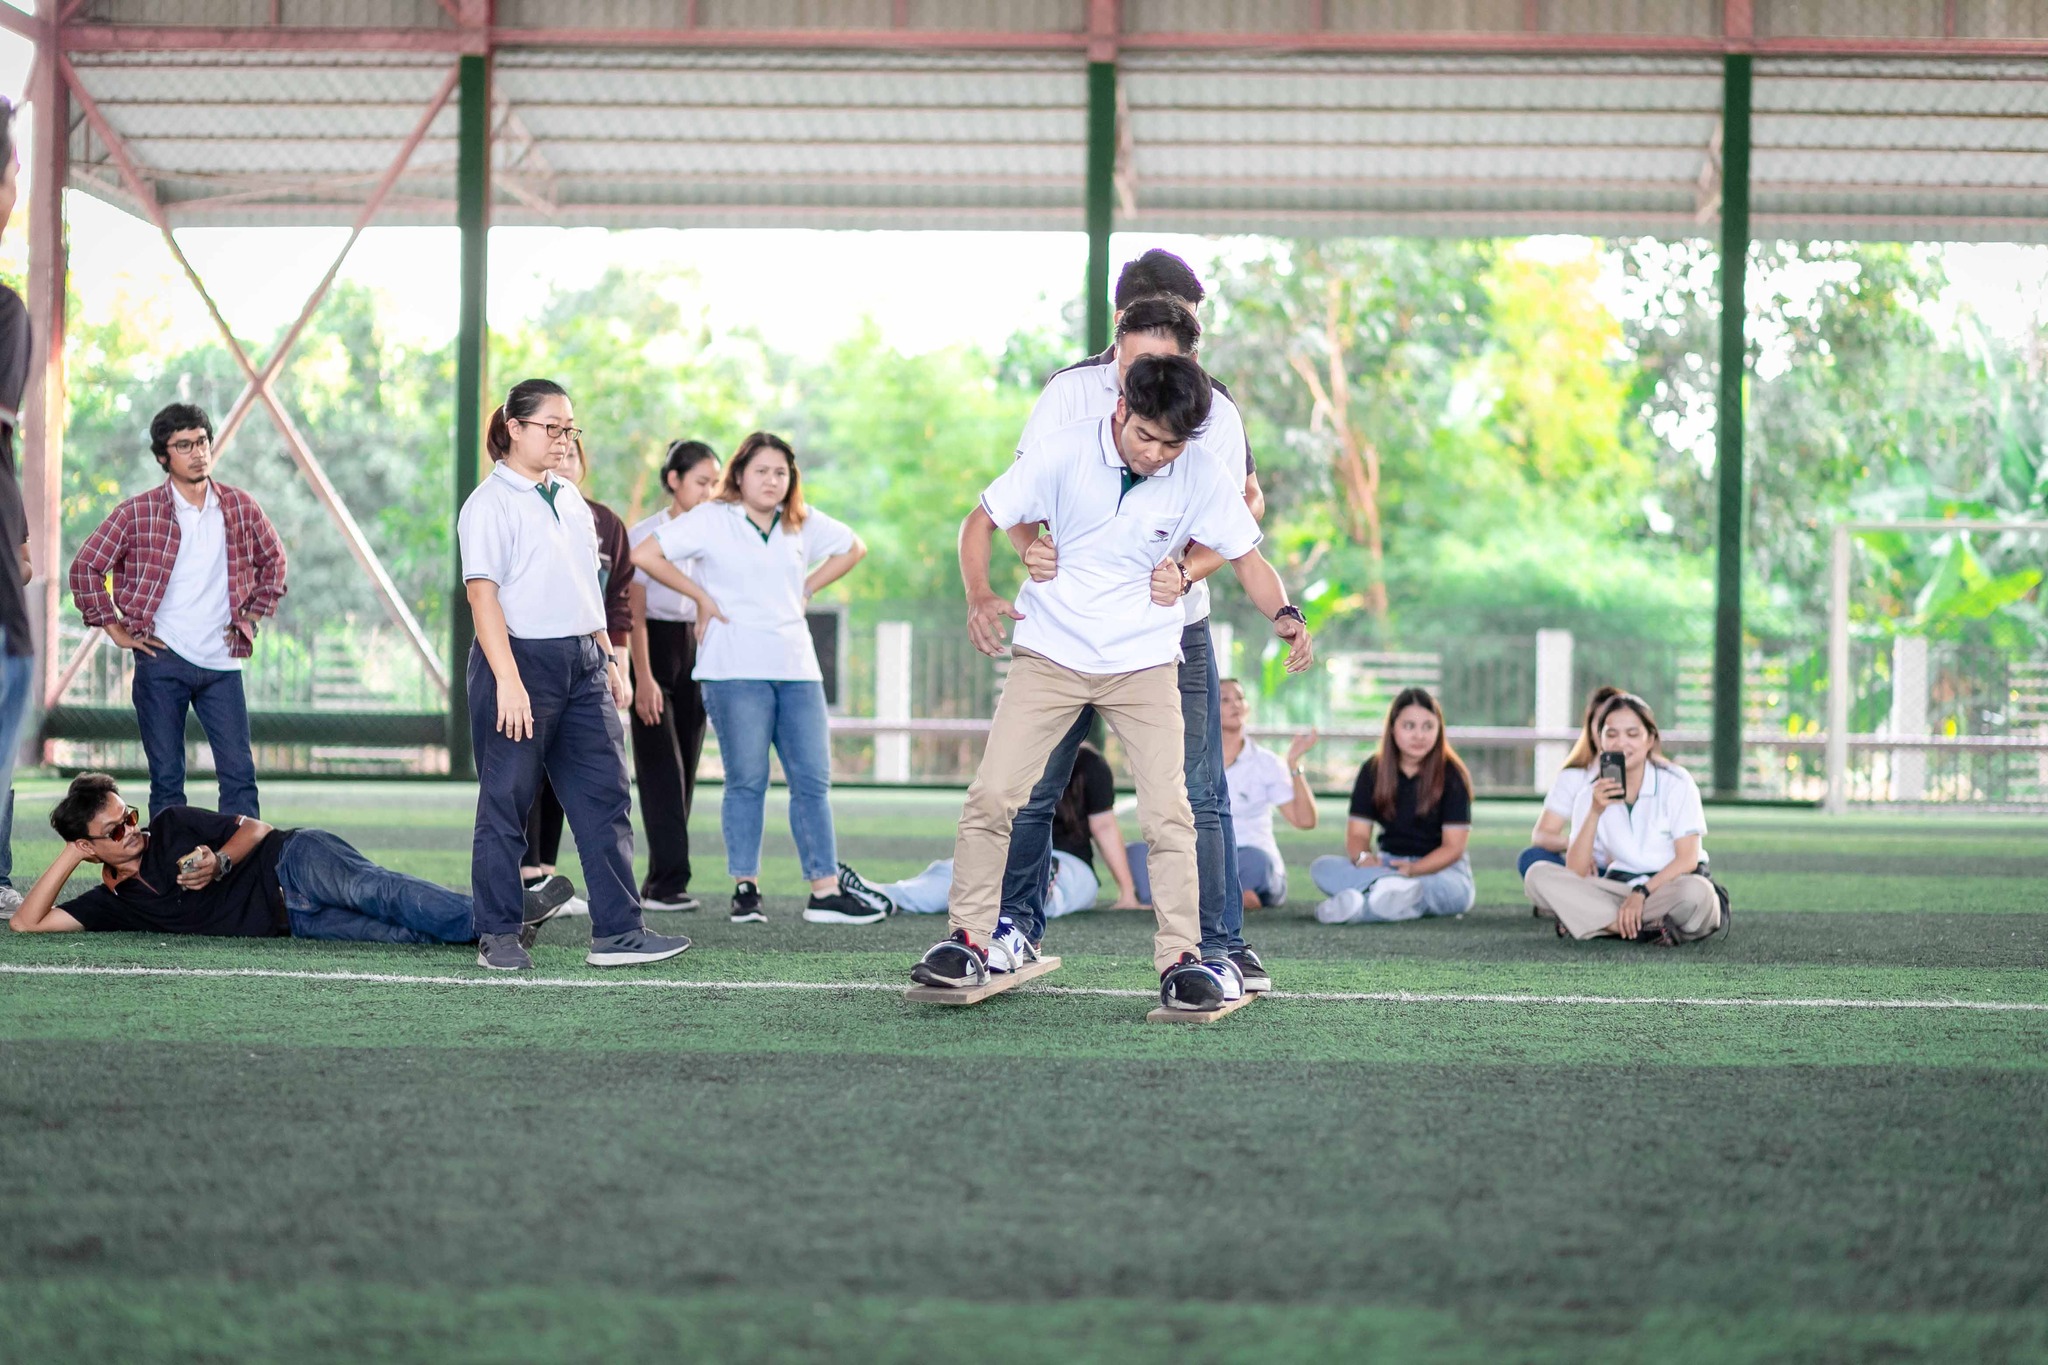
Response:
[449,55,492,780]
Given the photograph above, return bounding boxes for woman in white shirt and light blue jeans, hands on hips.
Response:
[633,432,889,925]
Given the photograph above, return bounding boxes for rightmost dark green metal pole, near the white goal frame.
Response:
[1714,53,1749,796]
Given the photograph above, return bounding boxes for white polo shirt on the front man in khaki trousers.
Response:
[981,417,1260,673]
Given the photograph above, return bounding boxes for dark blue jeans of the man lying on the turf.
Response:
[276,829,477,943]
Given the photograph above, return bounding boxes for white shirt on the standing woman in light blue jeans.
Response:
[653,501,854,681]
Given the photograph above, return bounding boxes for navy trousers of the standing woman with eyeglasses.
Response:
[469,634,641,939]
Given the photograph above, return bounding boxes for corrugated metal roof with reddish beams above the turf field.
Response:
[44,0,2048,241]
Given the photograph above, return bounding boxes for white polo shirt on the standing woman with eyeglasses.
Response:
[455,460,604,641]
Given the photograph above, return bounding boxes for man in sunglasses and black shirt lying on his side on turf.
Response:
[10,774,571,943]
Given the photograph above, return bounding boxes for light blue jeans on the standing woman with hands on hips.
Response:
[700,677,840,882]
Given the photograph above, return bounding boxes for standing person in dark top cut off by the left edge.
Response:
[0,98,35,915]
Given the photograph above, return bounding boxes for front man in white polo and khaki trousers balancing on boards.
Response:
[911,356,1313,1011]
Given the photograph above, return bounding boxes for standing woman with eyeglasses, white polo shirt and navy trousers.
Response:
[455,379,690,972]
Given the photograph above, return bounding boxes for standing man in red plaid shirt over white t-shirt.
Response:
[72,403,285,819]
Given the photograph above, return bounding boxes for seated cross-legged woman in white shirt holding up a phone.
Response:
[1522,692,1724,943]
